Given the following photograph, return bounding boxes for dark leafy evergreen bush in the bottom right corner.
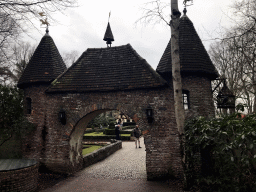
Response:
[185,113,256,191]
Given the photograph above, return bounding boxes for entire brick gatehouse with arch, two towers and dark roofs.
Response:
[18,11,218,179]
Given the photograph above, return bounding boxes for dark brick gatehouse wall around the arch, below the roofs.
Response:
[21,86,182,178]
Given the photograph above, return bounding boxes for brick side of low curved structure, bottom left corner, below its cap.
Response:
[0,164,38,192]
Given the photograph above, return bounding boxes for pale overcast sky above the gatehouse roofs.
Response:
[24,0,232,69]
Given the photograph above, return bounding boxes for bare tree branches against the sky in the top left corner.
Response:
[0,0,77,83]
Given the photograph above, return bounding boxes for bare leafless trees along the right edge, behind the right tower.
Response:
[210,0,256,113]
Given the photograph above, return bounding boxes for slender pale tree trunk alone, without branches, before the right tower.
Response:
[170,0,185,135]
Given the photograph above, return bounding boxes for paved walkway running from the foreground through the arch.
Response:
[40,139,179,192]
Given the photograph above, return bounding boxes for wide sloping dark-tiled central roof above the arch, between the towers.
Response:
[46,44,167,92]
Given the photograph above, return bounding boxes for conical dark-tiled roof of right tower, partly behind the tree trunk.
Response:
[156,15,219,79]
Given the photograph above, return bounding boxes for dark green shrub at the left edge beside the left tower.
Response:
[0,85,34,146]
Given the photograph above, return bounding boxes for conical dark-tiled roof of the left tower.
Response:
[18,33,67,88]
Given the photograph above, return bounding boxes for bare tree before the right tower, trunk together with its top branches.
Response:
[136,0,190,135]
